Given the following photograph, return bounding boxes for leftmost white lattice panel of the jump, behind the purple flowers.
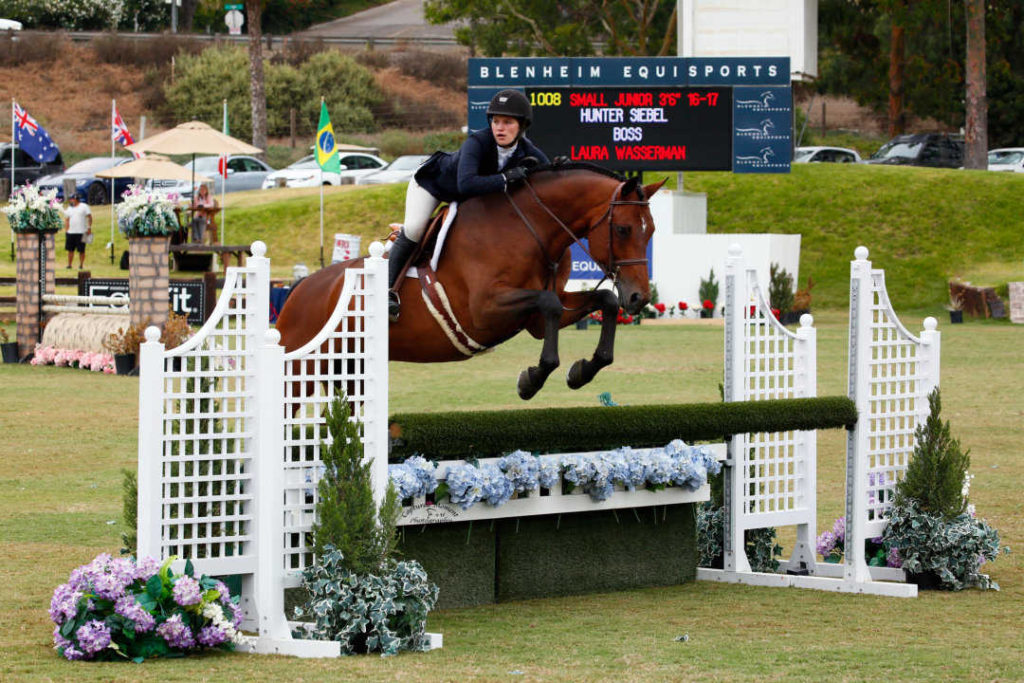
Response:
[140,268,267,573]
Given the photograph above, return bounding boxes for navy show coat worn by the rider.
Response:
[416,128,549,202]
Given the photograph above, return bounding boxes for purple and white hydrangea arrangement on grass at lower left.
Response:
[49,553,242,661]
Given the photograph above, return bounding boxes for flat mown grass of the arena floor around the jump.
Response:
[0,309,1024,681]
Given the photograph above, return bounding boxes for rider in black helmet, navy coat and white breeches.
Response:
[388,90,548,322]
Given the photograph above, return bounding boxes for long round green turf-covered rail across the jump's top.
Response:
[390,396,857,462]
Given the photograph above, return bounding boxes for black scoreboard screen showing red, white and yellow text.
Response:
[524,86,733,171]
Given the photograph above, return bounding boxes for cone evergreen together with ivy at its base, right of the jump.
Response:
[882,388,1009,591]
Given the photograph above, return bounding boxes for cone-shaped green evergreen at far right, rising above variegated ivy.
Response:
[896,387,971,519]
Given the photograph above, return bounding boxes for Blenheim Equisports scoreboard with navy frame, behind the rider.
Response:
[468,57,793,173]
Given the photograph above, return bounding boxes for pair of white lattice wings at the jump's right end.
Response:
[697,247,939,597]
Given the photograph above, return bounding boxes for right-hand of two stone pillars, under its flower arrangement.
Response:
[128,237,171,329]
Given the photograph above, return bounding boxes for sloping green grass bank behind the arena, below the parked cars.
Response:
[0,164,1024,308]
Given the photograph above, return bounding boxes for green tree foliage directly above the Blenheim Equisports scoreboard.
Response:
[424,0,677,56]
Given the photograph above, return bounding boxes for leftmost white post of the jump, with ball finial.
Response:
[135,327,164,561]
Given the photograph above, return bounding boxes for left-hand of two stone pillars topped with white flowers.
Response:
[14,232,55,358]
